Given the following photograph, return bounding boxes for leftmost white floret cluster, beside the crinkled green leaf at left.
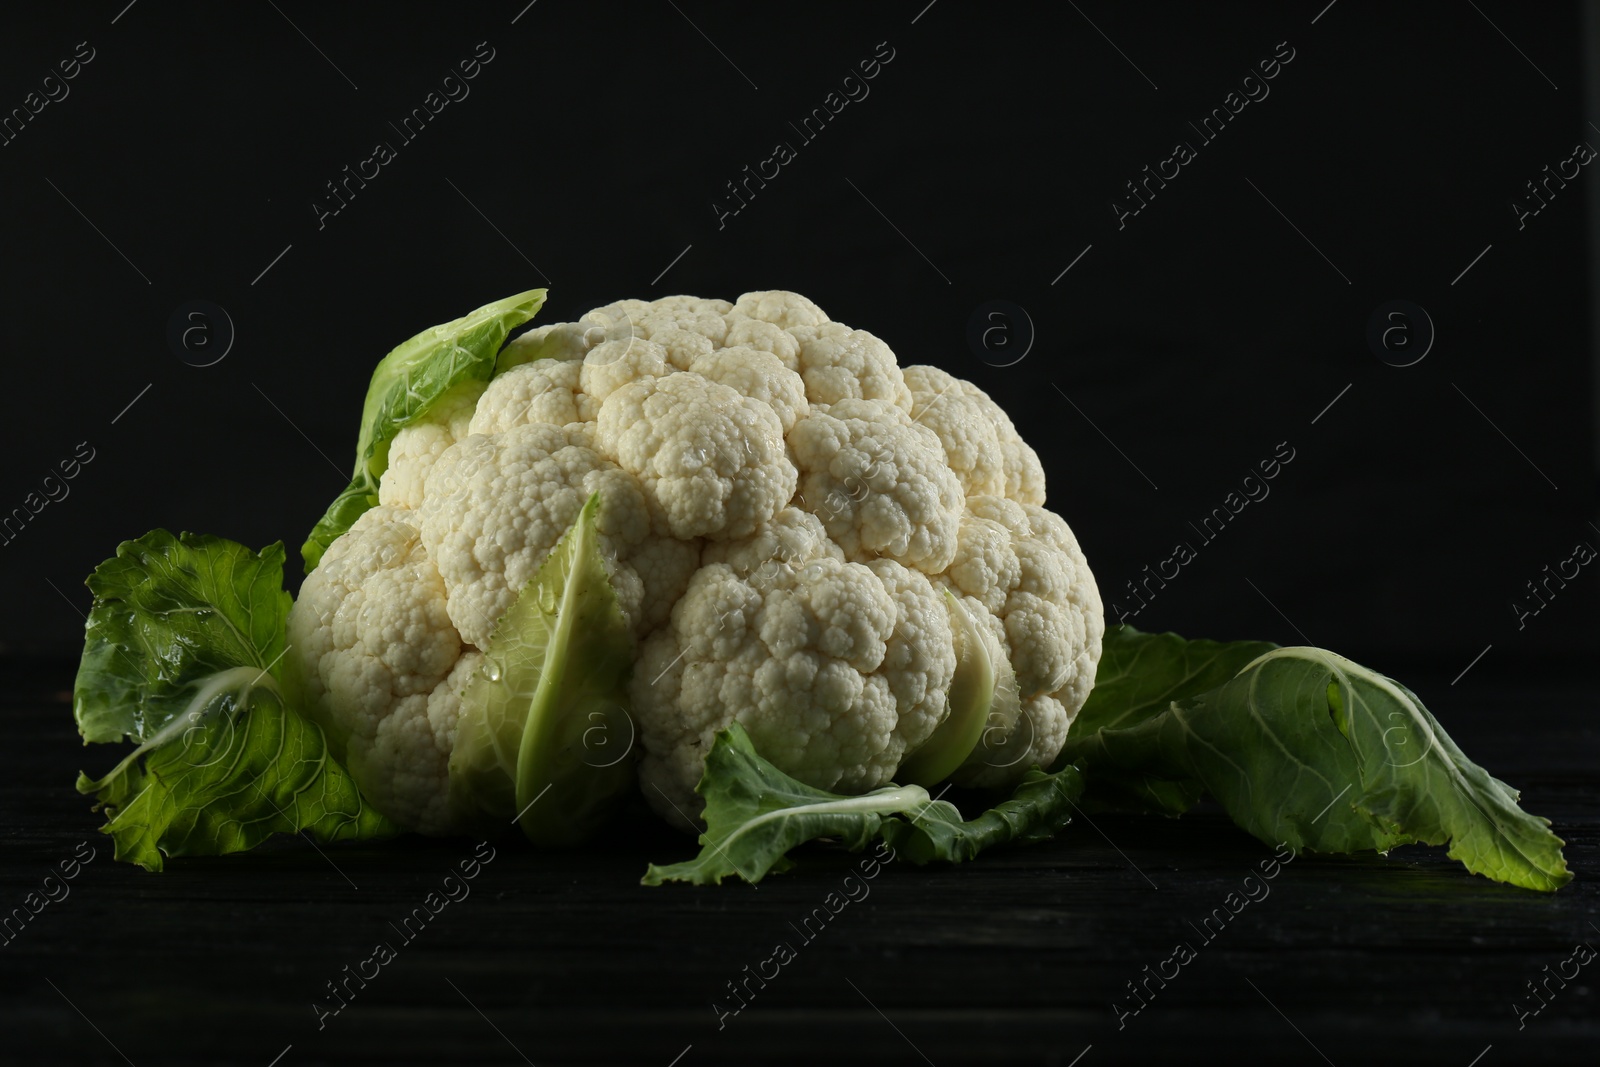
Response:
[288,507,467,833]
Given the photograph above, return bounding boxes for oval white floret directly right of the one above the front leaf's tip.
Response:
[789,400,963,574]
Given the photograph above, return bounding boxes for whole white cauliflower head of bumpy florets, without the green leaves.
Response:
[286,291,1104,833]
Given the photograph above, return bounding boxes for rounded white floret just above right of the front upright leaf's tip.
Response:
[595,373,798,539]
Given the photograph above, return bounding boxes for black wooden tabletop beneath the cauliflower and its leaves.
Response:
[0,664,1600,1067]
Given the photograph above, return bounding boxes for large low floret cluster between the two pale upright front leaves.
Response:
[632,547,955,827]
